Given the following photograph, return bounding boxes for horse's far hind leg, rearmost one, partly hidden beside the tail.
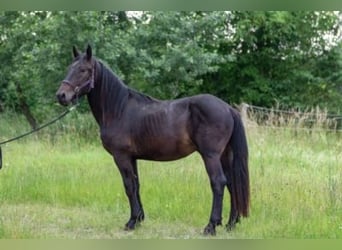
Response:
[221,146,240,231]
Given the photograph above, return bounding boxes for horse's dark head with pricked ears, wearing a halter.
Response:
[56,45,95,106]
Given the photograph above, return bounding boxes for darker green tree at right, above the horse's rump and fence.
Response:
[202,12,339,110]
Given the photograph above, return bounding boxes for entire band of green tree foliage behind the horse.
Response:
[0,11,342,125]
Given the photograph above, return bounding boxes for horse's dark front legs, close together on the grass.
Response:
[114,155,144,230]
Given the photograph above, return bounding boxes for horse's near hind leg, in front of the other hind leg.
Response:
[202,154,226,235]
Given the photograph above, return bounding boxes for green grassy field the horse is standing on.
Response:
[0,113,342,239]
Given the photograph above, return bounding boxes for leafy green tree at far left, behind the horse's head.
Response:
[0,11,136,128]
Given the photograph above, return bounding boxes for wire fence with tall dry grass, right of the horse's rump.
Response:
[239,103,342,133]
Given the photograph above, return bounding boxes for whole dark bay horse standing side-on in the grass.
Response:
[56,45,249,235]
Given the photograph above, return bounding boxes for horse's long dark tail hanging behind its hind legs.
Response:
[229,109,250,217]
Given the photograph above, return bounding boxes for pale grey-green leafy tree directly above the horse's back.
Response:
[125,12,226,99]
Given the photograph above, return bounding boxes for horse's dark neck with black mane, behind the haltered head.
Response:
[88,63,128,126]
